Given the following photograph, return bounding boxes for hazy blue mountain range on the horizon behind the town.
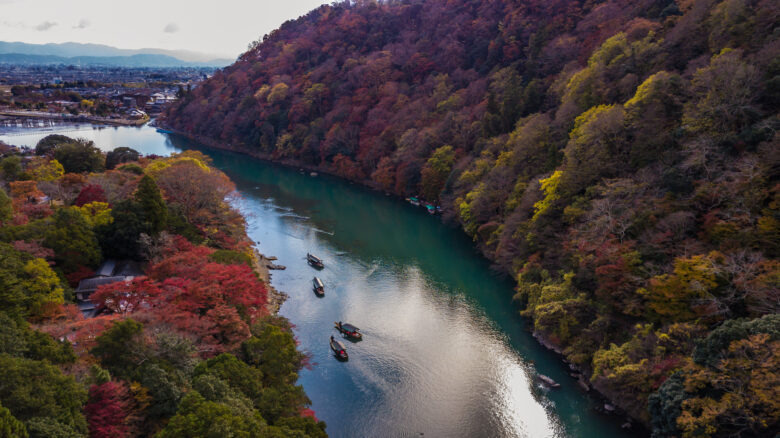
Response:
[0,41,233,67]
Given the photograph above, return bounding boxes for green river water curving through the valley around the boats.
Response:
[0,125,637,438]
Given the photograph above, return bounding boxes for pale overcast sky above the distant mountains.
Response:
[0,0,329,58]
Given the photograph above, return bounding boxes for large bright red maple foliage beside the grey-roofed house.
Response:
[92,239,267,356]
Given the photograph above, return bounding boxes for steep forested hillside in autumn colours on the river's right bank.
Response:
[165,0,780,437]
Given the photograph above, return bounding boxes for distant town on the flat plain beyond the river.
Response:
[0,65,215,125]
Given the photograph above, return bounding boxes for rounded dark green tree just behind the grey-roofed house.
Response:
[43,208,100,272]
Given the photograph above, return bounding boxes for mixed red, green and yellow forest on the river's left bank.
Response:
[0,135,327,438]
